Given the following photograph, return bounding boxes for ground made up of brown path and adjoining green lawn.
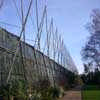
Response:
[60,85,100,100]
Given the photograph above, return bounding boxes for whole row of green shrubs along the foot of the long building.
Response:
[0,79,63,100]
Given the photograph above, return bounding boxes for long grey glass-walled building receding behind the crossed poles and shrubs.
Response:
[0,28,77,85]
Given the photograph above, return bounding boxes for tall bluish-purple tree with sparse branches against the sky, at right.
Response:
[82,9,100,67]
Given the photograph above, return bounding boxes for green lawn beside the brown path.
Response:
[82,85,100,100]
